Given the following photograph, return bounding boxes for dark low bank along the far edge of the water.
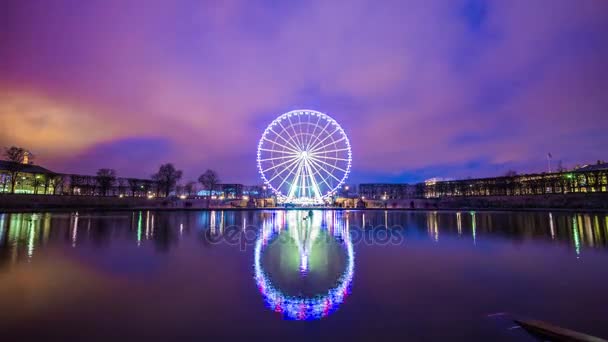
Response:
[0,193,608,212]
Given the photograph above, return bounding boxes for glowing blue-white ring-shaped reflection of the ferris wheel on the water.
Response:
[254,211,355,320]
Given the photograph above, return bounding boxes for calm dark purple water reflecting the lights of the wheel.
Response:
[0,211,608,341]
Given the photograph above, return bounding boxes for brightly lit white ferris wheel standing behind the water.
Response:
[257,110,352,204]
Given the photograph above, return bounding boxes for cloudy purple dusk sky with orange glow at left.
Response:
[0,0,608,184]
